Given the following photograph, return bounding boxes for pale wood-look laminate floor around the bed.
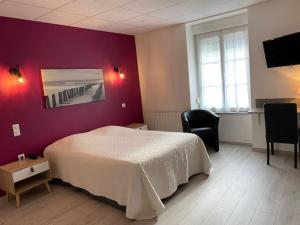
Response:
[0,144,300,225]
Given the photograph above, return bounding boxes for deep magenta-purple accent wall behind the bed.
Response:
[0,17,143,165]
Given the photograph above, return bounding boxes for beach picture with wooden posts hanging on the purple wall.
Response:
[41,69,105,109]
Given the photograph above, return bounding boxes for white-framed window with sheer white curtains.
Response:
[196,27,250,112]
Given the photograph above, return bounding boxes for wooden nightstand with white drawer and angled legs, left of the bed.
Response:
[0,158,52,207]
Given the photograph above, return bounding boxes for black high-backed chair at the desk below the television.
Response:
[264,103,300,168]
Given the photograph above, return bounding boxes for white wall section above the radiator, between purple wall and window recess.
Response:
[135,25,190,112]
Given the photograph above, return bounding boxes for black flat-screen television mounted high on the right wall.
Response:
[263,32,300,68]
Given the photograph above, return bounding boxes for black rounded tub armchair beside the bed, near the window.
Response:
[181,109,219,151]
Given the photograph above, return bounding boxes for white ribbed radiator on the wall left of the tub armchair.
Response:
[144,111,182,132]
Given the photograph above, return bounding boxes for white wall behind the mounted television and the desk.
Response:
[248,0,300,150]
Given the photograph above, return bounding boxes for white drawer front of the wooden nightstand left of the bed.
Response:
[12,161,49,183]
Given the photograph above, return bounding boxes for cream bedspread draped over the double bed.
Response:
[45,126,211,219]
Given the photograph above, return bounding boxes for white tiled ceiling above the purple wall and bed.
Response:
[0,0,267,34]
